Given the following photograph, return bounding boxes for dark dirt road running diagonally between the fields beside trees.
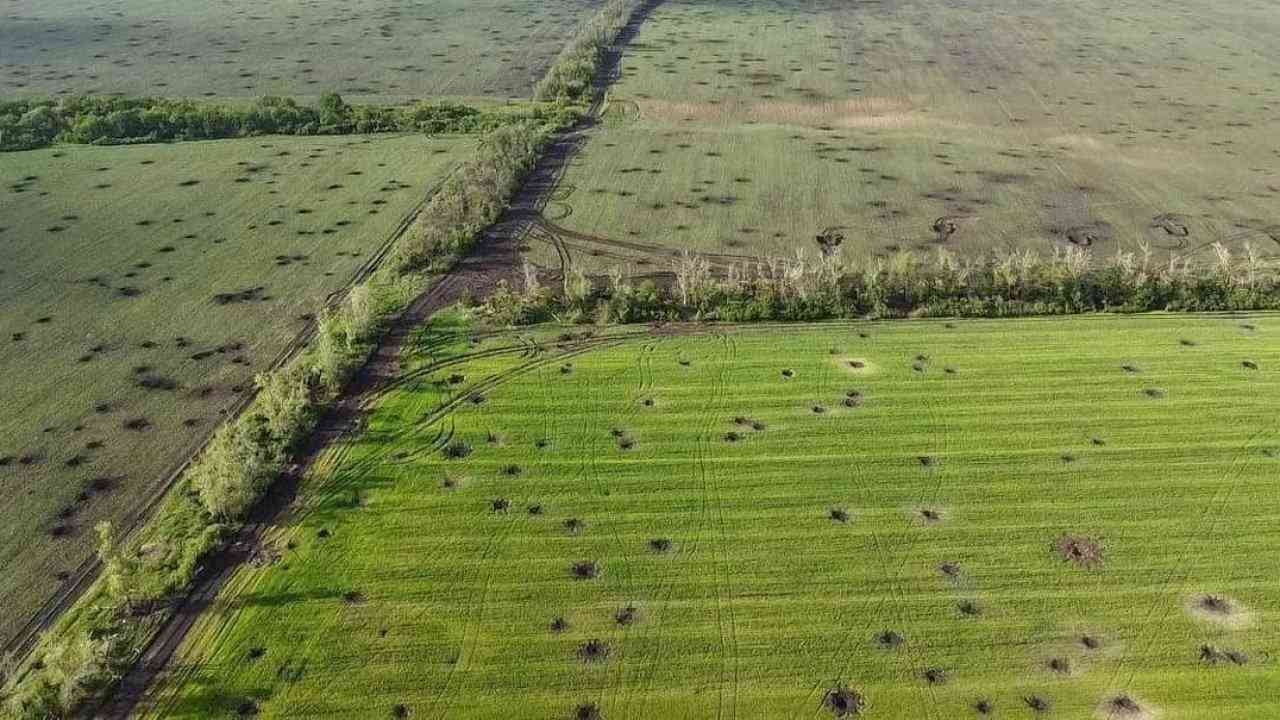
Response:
[93,0,663,720]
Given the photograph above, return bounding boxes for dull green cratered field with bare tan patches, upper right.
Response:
[522,0,1280,273]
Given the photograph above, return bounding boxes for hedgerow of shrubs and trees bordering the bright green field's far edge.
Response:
[489,245,1280,323]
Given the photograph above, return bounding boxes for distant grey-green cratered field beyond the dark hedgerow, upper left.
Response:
[0,0,598,101]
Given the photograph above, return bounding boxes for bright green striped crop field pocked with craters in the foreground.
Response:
[150,314,1280,720]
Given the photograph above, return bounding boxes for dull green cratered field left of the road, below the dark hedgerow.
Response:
[0,136,474,639]
